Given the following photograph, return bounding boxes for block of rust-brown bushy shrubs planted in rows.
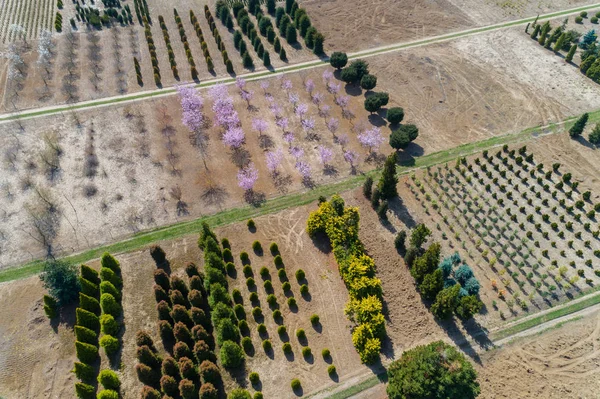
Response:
[136,247,221,398]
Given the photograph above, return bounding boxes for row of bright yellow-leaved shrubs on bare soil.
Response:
[307,195,385,363]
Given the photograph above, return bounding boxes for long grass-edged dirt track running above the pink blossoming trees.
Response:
[0,3,600,124]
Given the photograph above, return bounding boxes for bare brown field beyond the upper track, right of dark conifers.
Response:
[301,0,595,52]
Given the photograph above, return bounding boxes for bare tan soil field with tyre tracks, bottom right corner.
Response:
[477,313,600,399]
